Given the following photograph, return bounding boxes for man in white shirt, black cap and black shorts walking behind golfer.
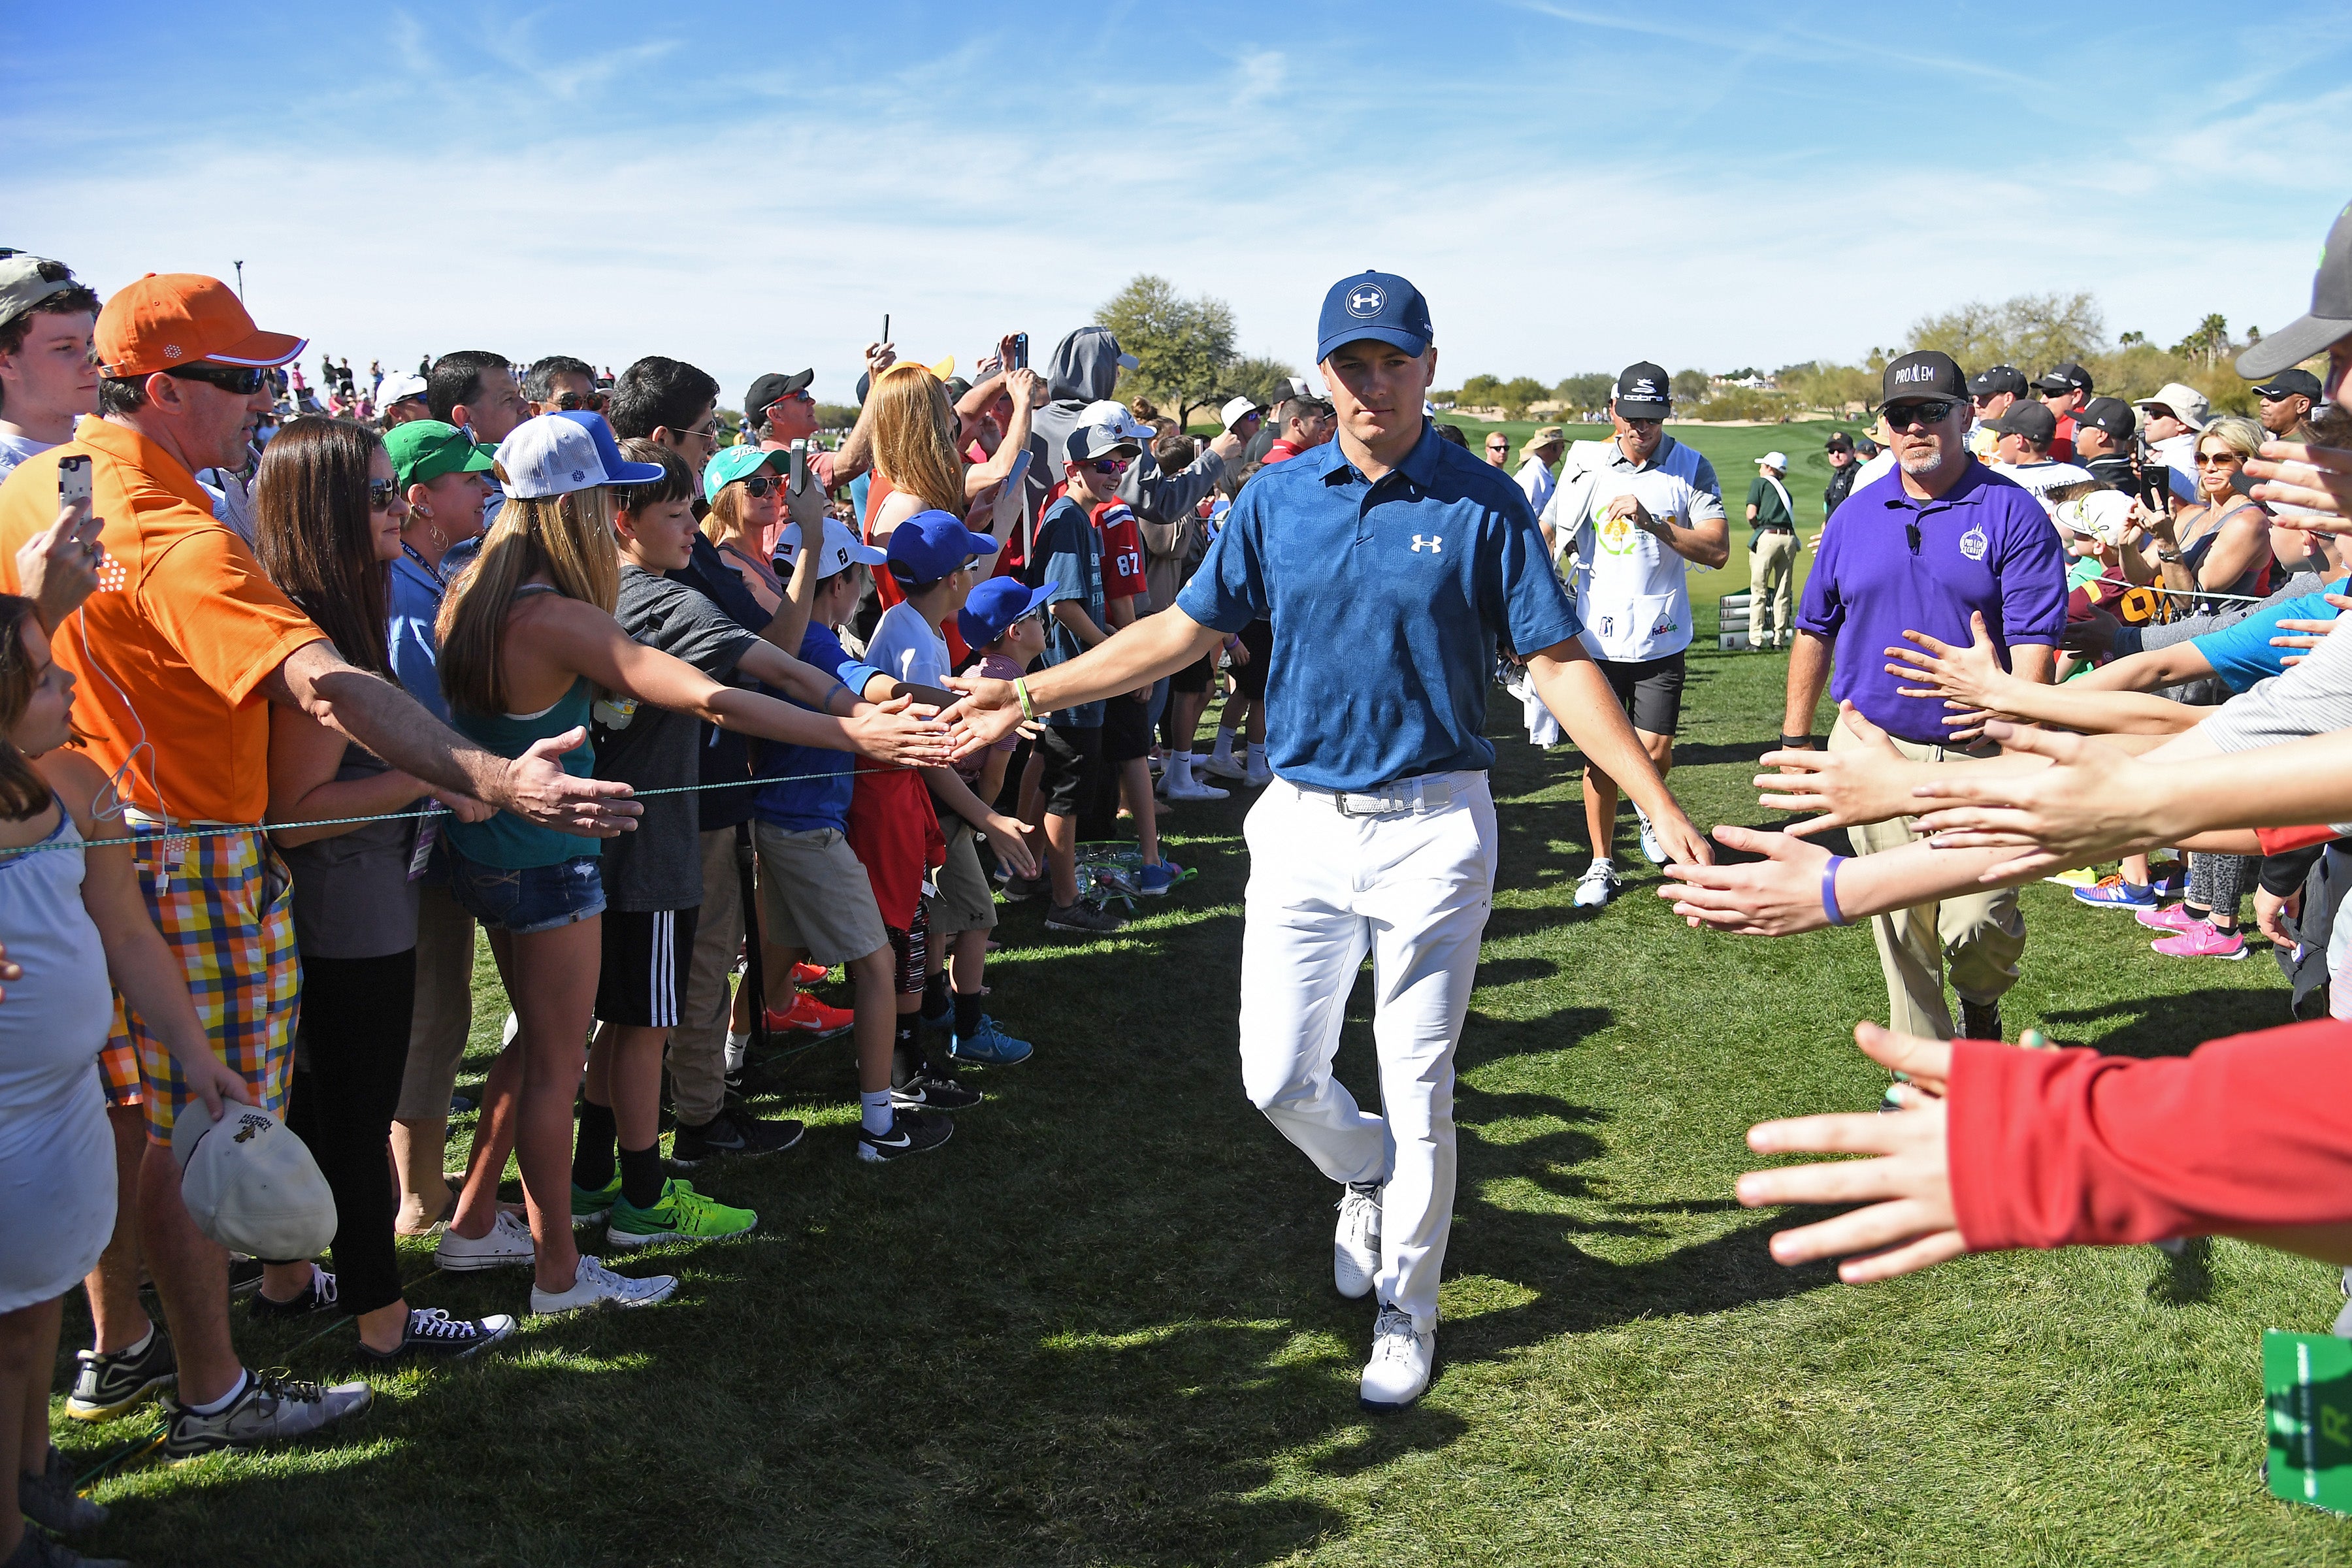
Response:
[1543,362,1731,910]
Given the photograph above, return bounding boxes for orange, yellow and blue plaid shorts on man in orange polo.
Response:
[129,825,301,1145]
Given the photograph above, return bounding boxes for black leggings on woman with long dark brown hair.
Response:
[287,947,416,1316]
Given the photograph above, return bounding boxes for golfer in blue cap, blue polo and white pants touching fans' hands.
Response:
[950,272,1708,1408]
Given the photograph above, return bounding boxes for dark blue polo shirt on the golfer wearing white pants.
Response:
[1176,423,1580,790]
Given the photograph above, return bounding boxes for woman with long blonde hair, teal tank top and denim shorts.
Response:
[440,414,945,1312]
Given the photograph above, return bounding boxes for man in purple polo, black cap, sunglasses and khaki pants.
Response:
[1780,353,2065,1039]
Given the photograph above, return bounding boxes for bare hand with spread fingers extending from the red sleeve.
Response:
[1736,1022,1968,1286]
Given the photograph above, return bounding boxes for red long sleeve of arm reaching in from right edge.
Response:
[1945,1021,2352,1250]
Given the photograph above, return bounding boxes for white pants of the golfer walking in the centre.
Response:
[1242,771,1496,1331]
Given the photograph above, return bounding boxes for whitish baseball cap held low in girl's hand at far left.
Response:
[172,1100,334,1262]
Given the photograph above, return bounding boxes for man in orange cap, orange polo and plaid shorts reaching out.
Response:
[0,272,640,1458]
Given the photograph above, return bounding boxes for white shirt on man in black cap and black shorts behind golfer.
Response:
[1543,435,1724,663]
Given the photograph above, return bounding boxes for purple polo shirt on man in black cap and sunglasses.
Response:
[1797,459,2067,745]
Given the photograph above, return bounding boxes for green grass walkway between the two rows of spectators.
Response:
[46,639,2352,1568]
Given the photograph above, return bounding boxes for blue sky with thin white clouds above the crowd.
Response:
[0,0,2352,402]
